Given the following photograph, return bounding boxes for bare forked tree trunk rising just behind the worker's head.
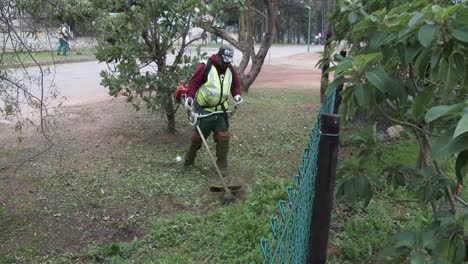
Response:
[199,0,278,92]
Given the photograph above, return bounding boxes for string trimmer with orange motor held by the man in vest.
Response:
[174,85,242,204]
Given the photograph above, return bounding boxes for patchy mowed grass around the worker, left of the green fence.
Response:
[0,86,320,263]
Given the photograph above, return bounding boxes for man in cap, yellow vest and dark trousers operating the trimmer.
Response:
[184,45,243,176]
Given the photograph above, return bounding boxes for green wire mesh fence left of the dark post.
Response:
[260,89,335,264]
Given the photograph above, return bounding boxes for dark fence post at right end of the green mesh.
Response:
[307,114,340,264]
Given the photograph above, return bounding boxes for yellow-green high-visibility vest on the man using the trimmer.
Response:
[195,60,232,112]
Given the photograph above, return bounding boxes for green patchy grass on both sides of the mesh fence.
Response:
[0,86,448,263]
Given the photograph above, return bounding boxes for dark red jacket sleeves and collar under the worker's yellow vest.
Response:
[187,54,241,98]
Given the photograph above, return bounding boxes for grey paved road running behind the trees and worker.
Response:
[3,45,323,122]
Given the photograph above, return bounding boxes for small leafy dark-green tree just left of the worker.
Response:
[96,0,203,133]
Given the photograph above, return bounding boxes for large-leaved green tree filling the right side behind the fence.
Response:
[329,0,468,263]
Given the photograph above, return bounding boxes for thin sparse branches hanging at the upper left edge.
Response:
[0,1,55,128]
